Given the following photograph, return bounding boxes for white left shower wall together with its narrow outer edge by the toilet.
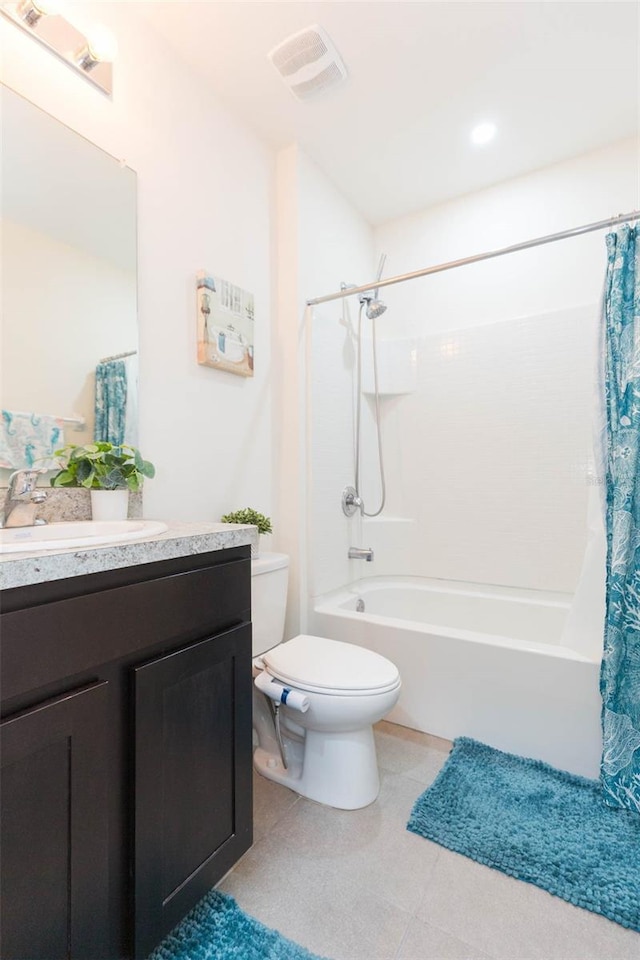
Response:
[274,146,373,636]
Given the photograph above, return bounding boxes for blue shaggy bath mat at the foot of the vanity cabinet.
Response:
[149,890,322,960]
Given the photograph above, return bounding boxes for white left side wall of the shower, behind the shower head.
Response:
[300,161,374,608]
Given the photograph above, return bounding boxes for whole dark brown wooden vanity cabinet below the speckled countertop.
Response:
[0,547,252,960]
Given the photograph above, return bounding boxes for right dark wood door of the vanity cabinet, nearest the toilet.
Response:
[133,624,252,958]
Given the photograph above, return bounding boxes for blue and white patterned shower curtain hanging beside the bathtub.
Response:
[600,224,640,813]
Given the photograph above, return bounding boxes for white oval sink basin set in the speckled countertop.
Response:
[0,520,169,554]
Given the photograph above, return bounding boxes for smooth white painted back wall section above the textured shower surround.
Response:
[376,139,640,336]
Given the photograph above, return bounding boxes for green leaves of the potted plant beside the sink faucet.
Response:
[51,440,156,490]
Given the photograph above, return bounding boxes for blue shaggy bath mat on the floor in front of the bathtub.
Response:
[407,737,640,931]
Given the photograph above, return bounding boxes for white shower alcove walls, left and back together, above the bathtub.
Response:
[306,140,640,608]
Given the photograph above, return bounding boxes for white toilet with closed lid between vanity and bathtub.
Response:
[251,553,401,810]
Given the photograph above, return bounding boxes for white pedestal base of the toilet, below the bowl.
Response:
[253,726,380,810]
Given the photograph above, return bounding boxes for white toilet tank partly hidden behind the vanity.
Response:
[251,553,289,657]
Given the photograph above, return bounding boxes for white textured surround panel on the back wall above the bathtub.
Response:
[366,306,597,591]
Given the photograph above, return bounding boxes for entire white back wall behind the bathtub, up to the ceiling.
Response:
[366,140,640,590]
